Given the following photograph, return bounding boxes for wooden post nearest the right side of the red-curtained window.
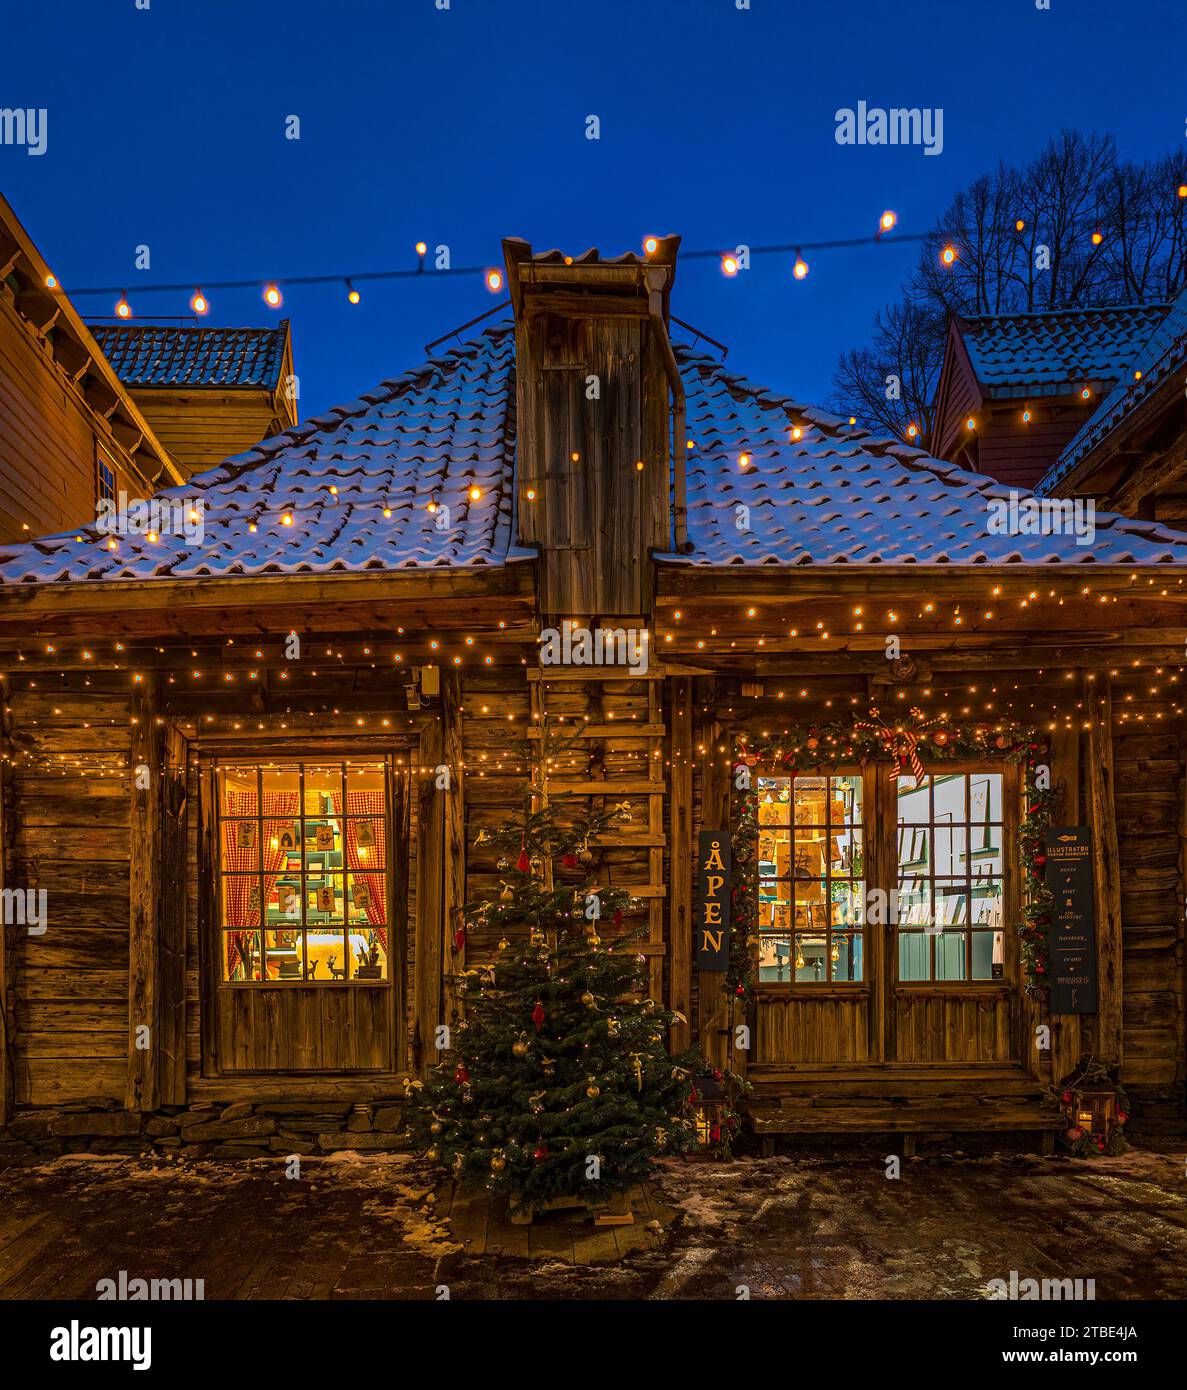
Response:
[411,721,446,1072]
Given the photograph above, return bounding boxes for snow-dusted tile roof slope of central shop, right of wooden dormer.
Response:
[660,346,1187,566]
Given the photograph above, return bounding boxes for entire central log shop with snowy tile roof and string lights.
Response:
[0,238,1187,1154]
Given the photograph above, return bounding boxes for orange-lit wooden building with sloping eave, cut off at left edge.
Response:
[0,197,182,541]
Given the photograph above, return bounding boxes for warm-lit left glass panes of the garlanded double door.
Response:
[753,774,865,984]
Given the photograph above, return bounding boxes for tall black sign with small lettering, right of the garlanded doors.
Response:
[1044,826,1097,1013]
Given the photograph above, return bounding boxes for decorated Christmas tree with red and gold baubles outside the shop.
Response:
[413,805,698,1211]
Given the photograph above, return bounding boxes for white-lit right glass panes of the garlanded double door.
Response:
[898,773,1004,981]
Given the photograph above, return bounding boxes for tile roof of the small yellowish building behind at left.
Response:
[90,320,288,391]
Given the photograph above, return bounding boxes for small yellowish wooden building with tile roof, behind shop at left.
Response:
[92,318,297,477]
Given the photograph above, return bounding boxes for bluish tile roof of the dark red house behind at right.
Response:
[958,303,1170,399]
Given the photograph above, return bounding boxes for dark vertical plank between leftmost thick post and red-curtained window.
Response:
[157,727,189,1105]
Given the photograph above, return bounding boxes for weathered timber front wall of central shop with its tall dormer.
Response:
[0,243,1187,1151]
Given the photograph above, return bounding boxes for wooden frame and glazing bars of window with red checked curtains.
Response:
[211,748,397,994]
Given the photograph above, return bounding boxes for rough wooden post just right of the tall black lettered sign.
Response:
[1084,671,1123,1066]
